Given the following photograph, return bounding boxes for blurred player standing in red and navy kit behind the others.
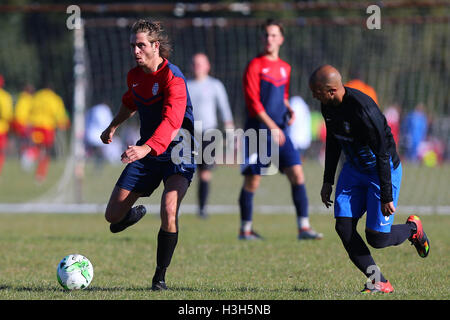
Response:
[239,20,323,240]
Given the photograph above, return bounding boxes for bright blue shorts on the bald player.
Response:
[334,162,402,233]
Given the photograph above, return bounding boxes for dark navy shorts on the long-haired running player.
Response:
[116,157,196,197]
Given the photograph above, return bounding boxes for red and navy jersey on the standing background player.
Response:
[243,55,291,128]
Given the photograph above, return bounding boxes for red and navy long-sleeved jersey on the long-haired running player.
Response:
[122,59,194,159]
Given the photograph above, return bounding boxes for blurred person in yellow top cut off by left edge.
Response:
[0,75,13,173]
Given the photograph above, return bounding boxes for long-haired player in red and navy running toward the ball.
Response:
[101,20,195,291]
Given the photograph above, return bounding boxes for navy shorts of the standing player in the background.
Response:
[241,130,302,175]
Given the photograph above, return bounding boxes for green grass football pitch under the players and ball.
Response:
[0,160,450,300]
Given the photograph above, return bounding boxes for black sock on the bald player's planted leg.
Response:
[336,218,386,282]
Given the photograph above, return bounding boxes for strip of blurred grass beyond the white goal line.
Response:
[0,160,450,206]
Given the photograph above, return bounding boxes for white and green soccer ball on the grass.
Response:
[56,254,94,290]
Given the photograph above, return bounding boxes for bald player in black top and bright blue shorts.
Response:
[309,65,430,293]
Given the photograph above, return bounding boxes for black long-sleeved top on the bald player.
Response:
[321,87,400,203]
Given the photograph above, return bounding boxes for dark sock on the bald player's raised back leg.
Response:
[366,223,415,249]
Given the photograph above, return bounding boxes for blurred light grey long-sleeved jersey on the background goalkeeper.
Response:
[187,76,233,131]
